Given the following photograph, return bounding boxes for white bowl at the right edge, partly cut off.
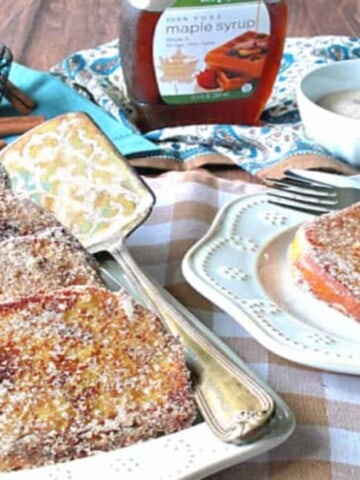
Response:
[297,58,360,166]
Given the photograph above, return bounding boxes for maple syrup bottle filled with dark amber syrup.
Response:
[120,0,287,131]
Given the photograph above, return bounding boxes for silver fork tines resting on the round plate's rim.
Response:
[265,171,360,215]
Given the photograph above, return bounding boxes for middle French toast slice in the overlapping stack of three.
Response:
[0,227,103,303]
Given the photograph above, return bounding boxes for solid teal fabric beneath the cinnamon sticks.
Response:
[3,63,159,157]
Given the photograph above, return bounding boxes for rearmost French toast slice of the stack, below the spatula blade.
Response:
[0,190,62,242]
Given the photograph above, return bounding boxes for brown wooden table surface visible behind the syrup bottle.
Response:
[0,0,360,70]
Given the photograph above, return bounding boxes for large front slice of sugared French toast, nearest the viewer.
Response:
[0,287,196,471]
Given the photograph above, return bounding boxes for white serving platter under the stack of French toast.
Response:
[0,259,295,480]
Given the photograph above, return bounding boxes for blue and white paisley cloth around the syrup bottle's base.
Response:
[51,36,360,174]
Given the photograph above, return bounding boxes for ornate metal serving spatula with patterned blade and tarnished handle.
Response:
[0,114,274,443]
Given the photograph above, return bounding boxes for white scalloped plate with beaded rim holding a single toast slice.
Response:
[182,193,360,374]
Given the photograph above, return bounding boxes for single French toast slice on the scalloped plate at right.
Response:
[288,203,360,321]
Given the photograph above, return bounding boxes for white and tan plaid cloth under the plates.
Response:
[128,171,360,480]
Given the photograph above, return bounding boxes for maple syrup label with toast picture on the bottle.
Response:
[153,0,270,104]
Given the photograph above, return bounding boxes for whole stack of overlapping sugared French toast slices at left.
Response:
[0,165,196,471]
